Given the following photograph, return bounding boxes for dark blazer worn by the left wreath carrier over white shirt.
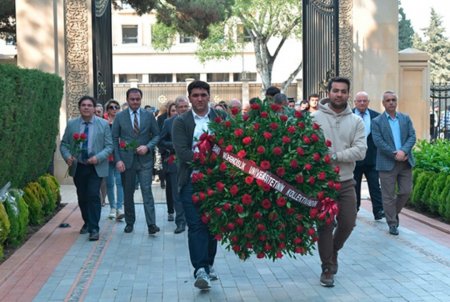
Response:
[172,108,226,188]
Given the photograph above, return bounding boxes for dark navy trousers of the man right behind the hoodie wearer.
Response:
[353,165,383,215]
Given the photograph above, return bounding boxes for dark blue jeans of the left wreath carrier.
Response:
[179,183,217,277]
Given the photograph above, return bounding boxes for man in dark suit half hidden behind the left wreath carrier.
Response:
[158,96,189,234]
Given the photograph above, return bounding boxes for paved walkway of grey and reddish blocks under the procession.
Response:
[0,183,450,302]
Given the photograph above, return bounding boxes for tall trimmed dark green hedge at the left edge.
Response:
[0,65,63,188]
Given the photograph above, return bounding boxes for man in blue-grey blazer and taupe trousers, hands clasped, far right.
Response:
[372,91,416,235]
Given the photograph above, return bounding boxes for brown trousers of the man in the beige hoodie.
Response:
[318,179,356,267]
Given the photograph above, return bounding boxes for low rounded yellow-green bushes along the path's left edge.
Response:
[0,174,61,259]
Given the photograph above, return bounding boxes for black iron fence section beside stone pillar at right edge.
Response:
[430,83,450,140]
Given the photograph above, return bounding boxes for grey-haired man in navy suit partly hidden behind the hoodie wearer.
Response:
[353,91,384,220]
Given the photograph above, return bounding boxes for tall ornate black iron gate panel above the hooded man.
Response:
[303,0,339,98]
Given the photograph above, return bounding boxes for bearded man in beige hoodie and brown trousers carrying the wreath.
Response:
[312,77,367,287]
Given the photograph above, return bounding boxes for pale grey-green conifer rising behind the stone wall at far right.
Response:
[414,8,450,82]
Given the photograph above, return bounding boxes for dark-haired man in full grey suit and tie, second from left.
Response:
[112,88,160,235]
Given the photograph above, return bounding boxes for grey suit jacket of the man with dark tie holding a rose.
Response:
[112,109,159,169]
